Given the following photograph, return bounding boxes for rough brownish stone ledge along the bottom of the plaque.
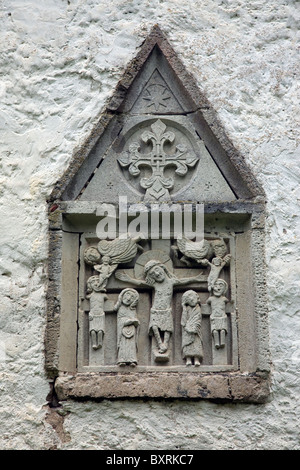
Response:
[55,372,270,403]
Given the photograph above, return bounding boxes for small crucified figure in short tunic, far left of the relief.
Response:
[86,276,107,349]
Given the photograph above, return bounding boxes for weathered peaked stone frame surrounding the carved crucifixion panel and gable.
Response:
[45,27,270,403]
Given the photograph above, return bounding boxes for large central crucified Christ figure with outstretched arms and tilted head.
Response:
[115,260,203,354]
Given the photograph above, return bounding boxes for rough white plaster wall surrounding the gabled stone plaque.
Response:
[0,0,300,449]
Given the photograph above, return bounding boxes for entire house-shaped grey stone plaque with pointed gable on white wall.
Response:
[45,27,270,403]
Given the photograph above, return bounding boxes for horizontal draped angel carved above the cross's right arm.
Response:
[172,237,212,266]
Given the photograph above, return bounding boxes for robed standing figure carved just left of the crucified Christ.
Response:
[114,289,140,366]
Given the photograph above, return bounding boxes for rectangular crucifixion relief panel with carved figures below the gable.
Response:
[79,235,237,371]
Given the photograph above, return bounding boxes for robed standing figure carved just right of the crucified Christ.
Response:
[181,290,203,366]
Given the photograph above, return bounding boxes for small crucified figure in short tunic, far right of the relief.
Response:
[207,279,229,349]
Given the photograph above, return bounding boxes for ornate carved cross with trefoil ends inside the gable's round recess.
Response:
[118,119,198,201]
